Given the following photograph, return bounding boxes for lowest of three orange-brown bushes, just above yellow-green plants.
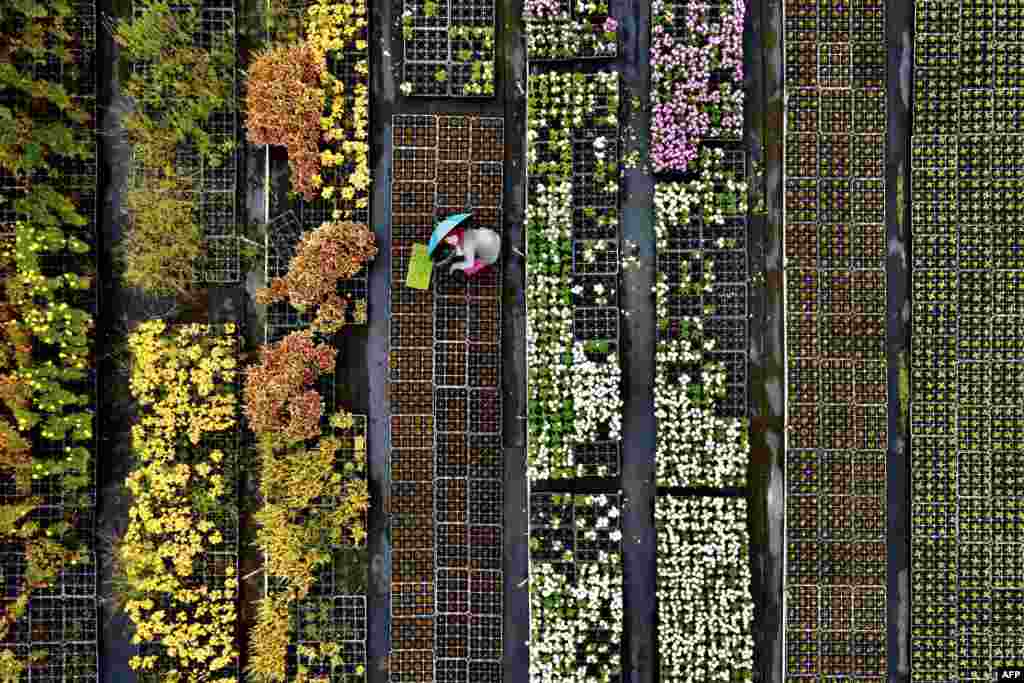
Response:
[239,331,338,443]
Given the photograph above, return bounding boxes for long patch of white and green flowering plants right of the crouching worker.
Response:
[526,73,623,479]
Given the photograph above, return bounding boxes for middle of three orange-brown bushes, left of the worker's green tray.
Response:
[256,222,377,333]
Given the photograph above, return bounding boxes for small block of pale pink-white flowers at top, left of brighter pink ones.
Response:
[525,0,618,59]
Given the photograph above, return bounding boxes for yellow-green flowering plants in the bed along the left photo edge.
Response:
[0,215,93,679]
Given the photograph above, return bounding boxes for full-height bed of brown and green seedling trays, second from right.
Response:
[784,0,888,680]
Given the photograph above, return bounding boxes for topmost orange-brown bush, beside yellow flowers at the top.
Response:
[246,43,326,200]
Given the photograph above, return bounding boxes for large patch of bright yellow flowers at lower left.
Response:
[118,321,239,683]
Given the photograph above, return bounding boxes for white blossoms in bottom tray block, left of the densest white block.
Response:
[529,496,623,683]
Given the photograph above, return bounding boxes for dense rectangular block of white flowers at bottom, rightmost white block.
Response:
[654,496,754,683]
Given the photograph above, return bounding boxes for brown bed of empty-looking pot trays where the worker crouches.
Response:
[388,115,504,683]
